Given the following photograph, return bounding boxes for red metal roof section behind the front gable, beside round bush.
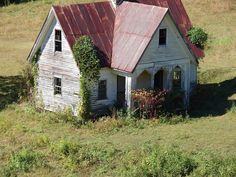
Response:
[137,0,204,58]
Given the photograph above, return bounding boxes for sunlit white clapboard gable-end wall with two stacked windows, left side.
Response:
[38,19,80,111]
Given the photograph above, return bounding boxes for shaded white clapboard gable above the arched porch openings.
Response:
[134,14,197,92]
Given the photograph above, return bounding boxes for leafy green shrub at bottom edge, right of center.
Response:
[130,147,197,177]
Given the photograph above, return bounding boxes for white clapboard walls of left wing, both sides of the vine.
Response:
[38,19,117,111]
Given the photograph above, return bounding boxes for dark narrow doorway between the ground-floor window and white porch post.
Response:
[117,76,125,108]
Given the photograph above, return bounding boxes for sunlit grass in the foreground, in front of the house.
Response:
[0,104,236,176]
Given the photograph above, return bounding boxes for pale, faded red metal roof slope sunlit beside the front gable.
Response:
[111,2,168,72]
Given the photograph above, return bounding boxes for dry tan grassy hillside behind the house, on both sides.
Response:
[0,0,236,75]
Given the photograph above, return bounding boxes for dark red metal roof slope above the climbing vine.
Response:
[53,2,115,66]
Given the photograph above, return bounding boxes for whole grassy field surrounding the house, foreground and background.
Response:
[0,0,236,177]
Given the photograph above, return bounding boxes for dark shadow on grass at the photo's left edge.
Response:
[0,76,22,110]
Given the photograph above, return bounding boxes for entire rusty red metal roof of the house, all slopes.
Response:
[53,0,204,72]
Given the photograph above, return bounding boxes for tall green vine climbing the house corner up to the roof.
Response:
[73,36,101,120]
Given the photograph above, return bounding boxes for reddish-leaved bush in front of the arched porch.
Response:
[132,89,167,119]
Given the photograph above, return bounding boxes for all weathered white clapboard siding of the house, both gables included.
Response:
[38,11,197,111]
